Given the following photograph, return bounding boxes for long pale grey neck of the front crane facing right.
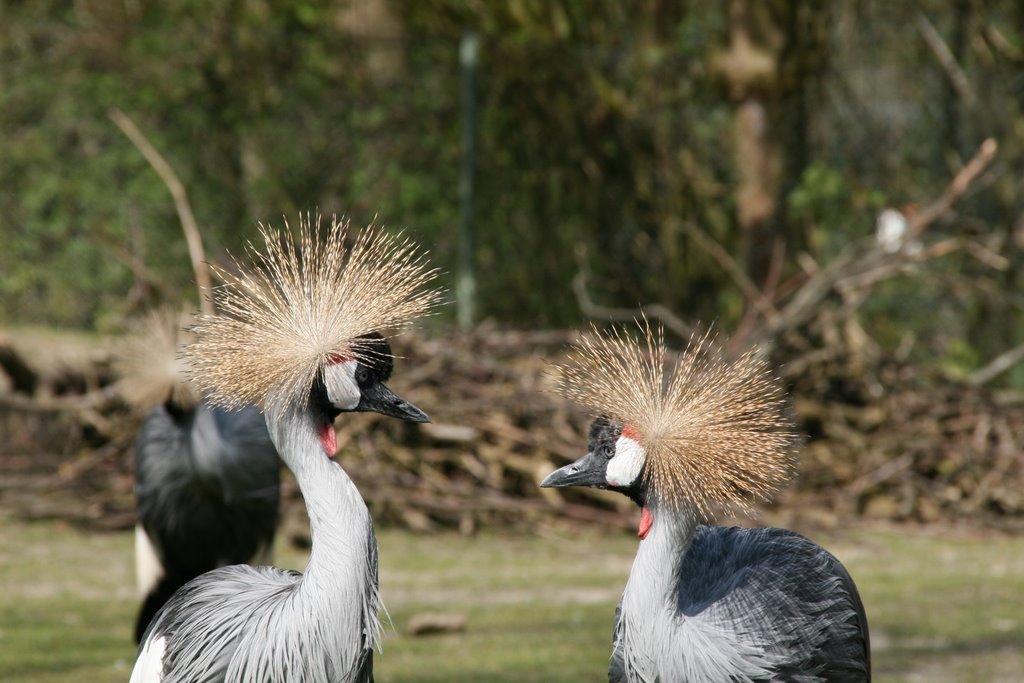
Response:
[266,397,381,671]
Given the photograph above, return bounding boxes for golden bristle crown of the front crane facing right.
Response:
[187,214,441,408]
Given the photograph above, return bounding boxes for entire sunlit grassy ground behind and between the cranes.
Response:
[0,518,1024,683]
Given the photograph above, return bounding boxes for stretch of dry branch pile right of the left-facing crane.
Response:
[790,339,1024,525]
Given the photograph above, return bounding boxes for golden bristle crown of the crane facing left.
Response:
[555,318,800,515]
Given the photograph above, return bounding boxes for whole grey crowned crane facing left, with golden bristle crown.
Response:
[541,323,870,683]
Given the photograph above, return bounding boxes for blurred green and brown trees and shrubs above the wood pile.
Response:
[0,0,1024,383]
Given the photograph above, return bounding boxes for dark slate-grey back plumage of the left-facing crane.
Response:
[608,525,870,683]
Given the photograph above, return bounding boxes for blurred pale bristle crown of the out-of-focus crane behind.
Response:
[114,309,199,409]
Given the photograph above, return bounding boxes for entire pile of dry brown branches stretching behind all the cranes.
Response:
[0,329,1024,532]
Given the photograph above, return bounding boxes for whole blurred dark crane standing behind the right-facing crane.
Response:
[119,311,281,643]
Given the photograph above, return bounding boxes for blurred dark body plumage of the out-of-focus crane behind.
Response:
[135,402,281,642]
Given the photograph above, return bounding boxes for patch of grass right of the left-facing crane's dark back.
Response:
[837,529,1024,682]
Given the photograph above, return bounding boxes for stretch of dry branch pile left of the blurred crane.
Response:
[0,330,139,527]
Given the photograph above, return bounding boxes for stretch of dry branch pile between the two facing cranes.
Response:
[327,329,632,531]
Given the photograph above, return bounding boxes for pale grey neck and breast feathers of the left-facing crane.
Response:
[613,505,770,683]
